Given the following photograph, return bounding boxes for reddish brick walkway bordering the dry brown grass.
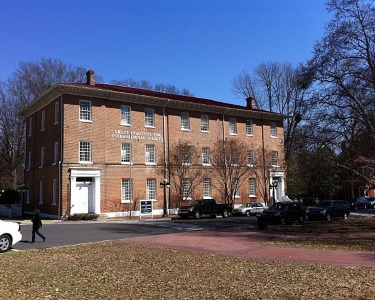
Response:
[124,231,375,268]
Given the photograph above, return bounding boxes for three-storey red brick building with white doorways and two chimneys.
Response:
[21,71,285,218]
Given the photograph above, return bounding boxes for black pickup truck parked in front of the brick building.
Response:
[178,199,232,219]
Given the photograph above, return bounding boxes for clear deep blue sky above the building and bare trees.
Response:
[0,0,330,105]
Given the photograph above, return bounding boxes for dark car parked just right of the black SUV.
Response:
[306,200,350,221]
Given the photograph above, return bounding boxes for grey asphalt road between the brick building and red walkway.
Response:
[14,217,257,250]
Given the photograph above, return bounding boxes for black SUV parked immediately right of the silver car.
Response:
[257,201,306,229]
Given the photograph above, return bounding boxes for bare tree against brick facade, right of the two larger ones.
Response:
[212,139,254,204]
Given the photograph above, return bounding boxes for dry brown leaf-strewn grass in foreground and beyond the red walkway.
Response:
[0,217,375,300]
